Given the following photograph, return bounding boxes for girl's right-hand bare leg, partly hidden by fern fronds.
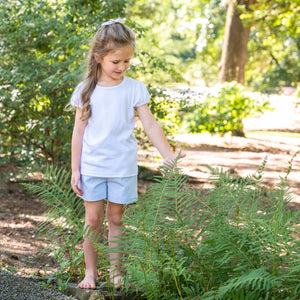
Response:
[106,202,124,288]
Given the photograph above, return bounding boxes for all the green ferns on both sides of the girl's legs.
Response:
[27,154,300,300]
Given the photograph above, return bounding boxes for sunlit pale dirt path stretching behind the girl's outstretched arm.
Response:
[140,134,300,209]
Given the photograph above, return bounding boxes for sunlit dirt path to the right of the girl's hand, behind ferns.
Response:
[180,136,300,205]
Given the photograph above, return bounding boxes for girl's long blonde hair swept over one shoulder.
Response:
[81,23,135,121]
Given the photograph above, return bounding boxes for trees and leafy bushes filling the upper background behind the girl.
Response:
[0,0,300,165]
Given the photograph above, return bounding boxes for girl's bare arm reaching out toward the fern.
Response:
[136,104,185,162]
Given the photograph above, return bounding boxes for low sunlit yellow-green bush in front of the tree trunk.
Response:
[184,82,269,136]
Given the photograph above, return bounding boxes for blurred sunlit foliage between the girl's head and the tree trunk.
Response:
[130,0,226,85]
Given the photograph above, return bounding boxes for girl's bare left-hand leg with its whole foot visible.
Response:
[78,200,104,289]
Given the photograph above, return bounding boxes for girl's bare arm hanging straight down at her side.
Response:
[71,107,87,196]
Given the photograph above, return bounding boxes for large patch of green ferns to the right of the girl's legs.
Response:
[122,155,299,300]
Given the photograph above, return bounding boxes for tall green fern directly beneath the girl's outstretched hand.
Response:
[119,161,199,299]
